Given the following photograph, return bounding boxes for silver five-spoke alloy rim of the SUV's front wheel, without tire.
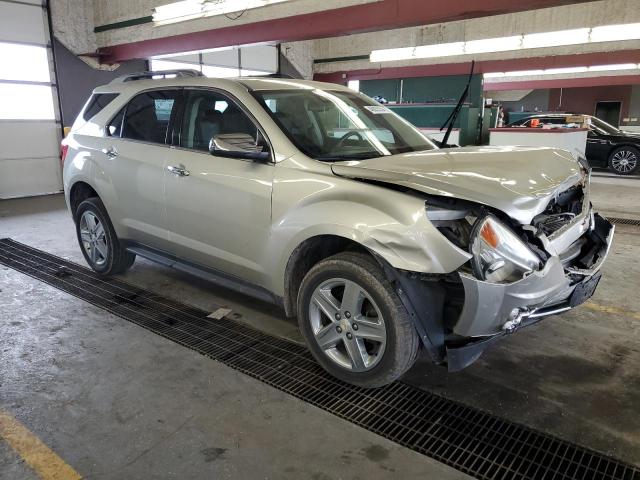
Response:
[309,278,387,372]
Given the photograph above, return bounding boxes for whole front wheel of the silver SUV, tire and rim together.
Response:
[298,252,420,388]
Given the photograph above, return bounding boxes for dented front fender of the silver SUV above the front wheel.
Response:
[267,158,471,294]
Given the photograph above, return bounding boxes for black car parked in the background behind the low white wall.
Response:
[507,113,640,175]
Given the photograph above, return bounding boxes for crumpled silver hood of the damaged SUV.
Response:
[331,147,583,224]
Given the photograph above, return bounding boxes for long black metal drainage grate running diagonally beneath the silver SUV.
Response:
[0,239,640,480]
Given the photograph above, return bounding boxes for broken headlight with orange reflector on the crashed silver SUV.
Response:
[471,215,540,283]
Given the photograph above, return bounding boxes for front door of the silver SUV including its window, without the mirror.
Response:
[165,90,274,284]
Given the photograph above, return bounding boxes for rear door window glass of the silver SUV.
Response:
[121,90,179,143]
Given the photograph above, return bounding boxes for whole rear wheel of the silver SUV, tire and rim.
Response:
[75,197,136,276]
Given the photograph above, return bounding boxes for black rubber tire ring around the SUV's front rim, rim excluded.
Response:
[298,253,417,387]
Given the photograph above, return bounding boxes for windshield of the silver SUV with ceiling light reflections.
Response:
[254,88,437,161]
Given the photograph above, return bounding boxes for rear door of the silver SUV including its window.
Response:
[96,89,180,249]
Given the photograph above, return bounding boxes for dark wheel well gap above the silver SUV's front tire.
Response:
[284,235,370,317]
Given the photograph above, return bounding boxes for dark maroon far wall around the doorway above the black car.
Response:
[549,85,631,117]
